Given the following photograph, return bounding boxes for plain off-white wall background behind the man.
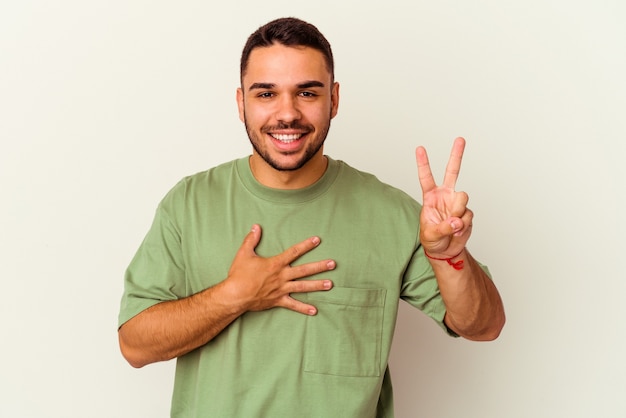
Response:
[0,0,626,418]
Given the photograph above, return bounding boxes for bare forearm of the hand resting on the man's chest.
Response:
[118,282,244,367]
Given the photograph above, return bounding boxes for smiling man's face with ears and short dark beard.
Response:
[237,44,339,171]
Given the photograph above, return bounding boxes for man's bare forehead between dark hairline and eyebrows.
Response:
[243,44,331,85]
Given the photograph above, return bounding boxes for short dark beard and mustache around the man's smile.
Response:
[244,114,330,171]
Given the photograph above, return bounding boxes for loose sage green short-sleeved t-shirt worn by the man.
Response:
[119,158,454,418]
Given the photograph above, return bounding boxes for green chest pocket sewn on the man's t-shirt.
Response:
[303,286,386,377]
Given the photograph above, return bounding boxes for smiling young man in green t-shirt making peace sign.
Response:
[119,18,504,418]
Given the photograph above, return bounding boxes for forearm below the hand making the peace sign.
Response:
[431,250,505,341]
